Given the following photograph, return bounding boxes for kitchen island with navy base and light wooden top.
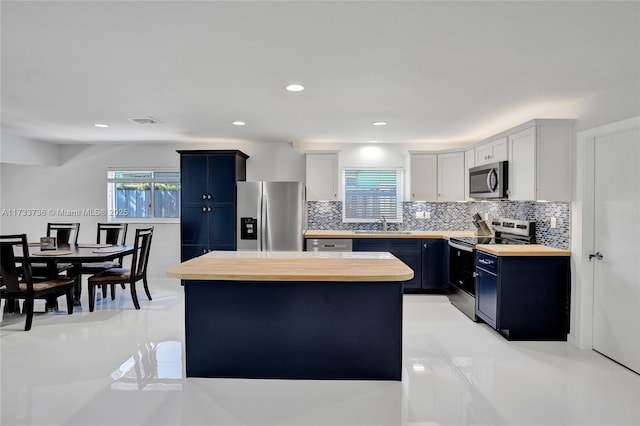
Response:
[168,251,413,380]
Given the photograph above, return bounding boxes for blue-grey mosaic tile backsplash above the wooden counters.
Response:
[307,201,571,249]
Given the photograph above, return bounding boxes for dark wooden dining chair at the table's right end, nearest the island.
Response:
[88,226,153,312]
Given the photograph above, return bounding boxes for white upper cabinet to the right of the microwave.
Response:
[508,120,573,201]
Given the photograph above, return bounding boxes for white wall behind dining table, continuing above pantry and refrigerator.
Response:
[0,142,305,277]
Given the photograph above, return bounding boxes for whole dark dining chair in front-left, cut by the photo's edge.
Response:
[0,234,75,331]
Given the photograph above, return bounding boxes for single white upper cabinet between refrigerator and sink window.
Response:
[306,153,339,201]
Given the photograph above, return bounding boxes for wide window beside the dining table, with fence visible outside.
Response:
[107,170,180,222]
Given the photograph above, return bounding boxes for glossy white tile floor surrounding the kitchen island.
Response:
[0,279,640,426]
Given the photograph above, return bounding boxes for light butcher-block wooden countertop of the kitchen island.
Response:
[167,251,413,282]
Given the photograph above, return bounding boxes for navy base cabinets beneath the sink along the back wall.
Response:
[353,238,447,292]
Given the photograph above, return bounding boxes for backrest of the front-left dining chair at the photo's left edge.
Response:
[0,234,33,292]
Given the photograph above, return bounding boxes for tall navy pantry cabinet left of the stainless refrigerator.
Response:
[178,150,249,262]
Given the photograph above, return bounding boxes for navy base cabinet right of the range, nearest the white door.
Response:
[476,251,570,340]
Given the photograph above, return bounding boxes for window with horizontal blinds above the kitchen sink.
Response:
[342,169,403,222]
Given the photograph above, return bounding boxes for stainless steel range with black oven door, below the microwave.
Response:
[449,218,536,321]
